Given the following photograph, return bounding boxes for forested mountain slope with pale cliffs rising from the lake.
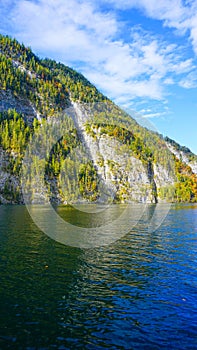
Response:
[0,35,197,203]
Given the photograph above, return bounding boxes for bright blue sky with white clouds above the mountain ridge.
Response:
[0,0,197,154]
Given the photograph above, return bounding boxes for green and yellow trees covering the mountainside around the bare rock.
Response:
[0,35,197,202]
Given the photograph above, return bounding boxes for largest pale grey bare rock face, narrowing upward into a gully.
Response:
[63,102,174,203]
